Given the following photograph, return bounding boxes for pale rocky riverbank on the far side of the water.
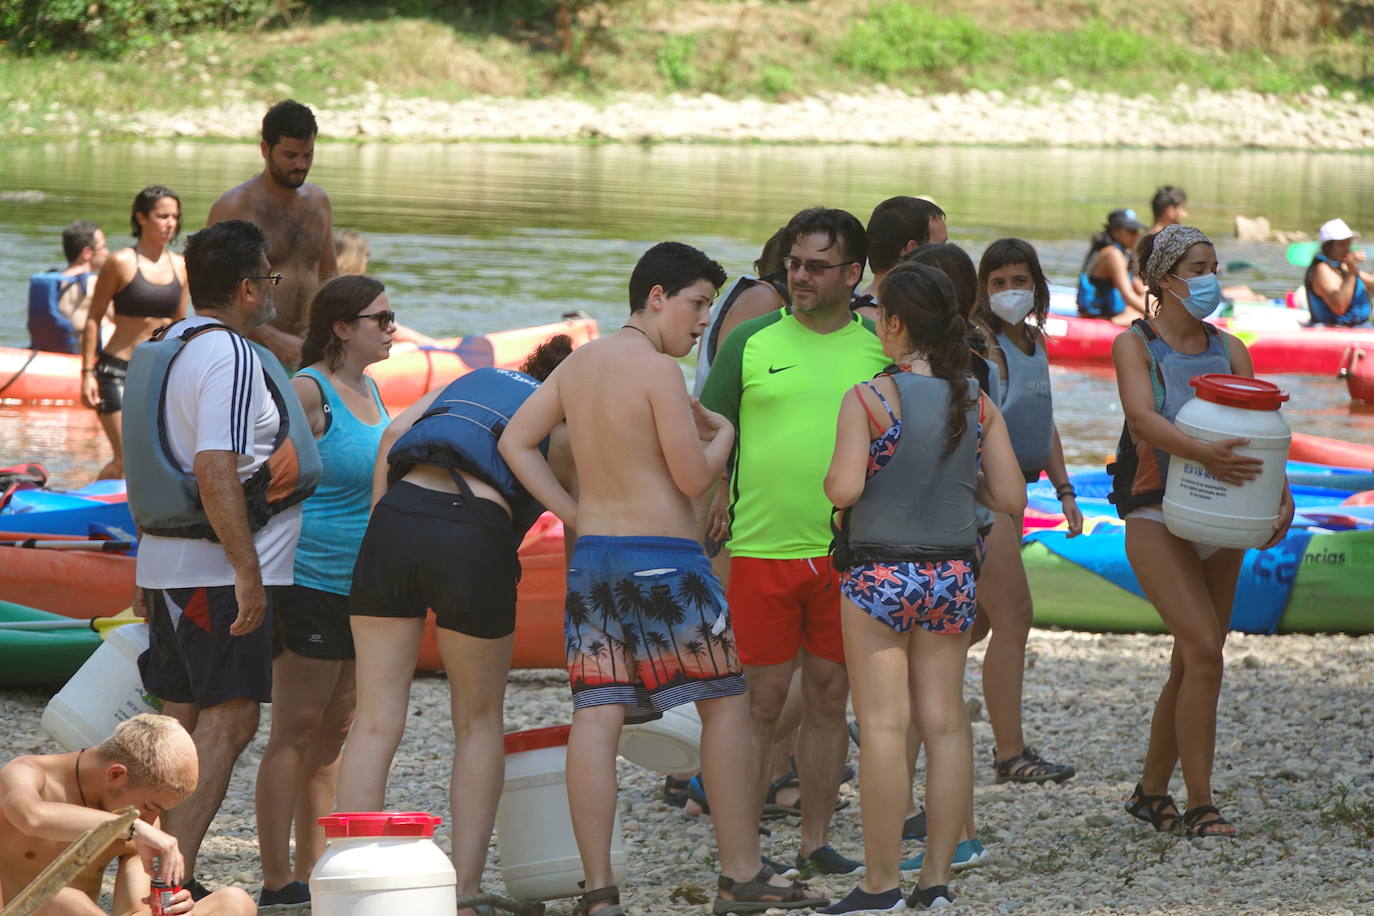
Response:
[8,80,1374,151]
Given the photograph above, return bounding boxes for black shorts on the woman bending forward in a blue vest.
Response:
[349,481,519,639]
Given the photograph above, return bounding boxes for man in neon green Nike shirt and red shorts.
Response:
[701,207,888,875]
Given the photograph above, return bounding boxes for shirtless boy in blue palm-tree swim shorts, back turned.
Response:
[499,242,824,916]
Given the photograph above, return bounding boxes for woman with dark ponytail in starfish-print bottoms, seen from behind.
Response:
[820,264,1025,913]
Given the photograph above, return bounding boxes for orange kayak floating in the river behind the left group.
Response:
[0,316,596,408]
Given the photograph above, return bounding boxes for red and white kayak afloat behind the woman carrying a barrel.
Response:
[1044,314,1374,375]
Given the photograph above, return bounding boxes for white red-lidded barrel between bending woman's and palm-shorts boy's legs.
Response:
[496,725,625,901]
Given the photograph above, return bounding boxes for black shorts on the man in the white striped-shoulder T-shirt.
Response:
[139,585,279,709]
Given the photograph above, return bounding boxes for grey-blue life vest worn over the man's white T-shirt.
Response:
[122,324,322,541]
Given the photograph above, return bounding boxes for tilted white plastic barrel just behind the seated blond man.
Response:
[43,623,162,751]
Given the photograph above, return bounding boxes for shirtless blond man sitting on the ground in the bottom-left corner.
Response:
[0,715,257,916]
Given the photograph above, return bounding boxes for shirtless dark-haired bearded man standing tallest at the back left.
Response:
[205,99,338,369]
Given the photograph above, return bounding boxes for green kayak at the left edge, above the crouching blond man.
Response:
[0,602,100,687]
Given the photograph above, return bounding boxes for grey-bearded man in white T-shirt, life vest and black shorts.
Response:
[124,220,320,900]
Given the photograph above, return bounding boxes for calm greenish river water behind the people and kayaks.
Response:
[0,140,1374,485]
